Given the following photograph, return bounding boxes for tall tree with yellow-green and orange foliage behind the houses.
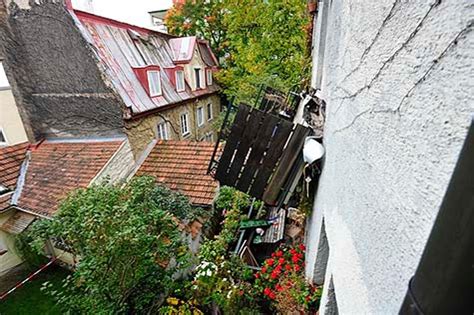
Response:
[167,0,310,102]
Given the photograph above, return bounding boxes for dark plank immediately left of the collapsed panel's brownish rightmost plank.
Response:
[249,120,293,199]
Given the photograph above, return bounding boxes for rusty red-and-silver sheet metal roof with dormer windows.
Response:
[75,15,219,113]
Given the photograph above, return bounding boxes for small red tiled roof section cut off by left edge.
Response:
[0,142,29,190]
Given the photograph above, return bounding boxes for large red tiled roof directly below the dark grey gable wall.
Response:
[18,141,122,216]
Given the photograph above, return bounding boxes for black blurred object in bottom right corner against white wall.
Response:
[400,120,474,315]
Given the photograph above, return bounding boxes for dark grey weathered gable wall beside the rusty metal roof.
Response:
[0,1,123,139]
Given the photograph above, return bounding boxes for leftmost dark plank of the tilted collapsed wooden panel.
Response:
[216,104,250,186]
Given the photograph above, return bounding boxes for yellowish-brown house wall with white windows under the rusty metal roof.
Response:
[126,94,220,155]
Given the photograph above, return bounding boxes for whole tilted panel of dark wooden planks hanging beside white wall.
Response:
[215,105,310,205]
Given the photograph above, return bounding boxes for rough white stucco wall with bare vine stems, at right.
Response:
[306,0,474,314]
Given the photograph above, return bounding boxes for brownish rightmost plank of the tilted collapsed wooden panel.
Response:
[262,125,310,205]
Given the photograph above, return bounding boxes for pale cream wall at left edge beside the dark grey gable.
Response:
[0,89,28,145]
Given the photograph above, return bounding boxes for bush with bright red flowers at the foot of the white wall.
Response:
[255,244,321,314]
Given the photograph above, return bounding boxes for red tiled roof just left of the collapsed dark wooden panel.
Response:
[136,140,217,205]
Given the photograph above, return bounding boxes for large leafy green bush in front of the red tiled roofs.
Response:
[25,177,191,314]
